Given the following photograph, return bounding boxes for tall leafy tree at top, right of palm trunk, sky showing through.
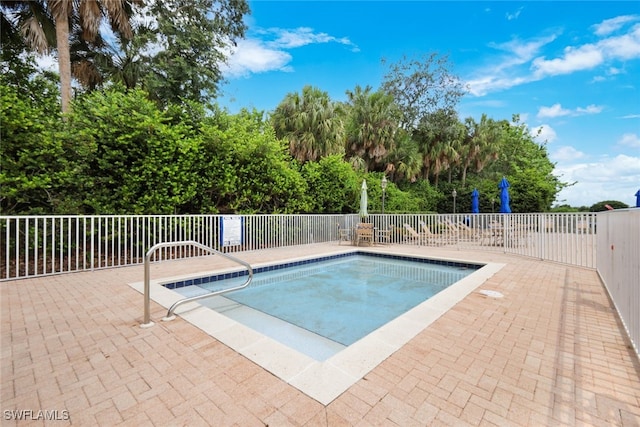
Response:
[140,0,249,104]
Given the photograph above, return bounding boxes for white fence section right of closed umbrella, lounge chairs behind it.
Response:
[368,213,597,268]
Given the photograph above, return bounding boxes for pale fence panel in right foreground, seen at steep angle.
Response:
[597,209,640,362]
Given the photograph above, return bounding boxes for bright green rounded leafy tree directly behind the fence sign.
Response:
[195,110,308,213]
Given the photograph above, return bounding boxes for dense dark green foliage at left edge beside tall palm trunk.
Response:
[0,65,81,215]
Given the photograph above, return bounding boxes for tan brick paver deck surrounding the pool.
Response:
[0,243,640,426]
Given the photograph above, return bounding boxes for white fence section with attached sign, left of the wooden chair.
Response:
[0,215,344,280]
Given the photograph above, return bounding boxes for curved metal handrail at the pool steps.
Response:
[140,240,253,328]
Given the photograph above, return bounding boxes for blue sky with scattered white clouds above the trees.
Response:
[217,1,640,206]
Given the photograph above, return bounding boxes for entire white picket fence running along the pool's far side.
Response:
[0,213,597,280]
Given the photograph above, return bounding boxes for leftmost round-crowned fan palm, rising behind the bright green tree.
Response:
[271,86,344,162]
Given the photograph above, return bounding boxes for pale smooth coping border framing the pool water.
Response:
[130,246,503,405]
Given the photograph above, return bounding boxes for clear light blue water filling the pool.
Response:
[166,253,480,360]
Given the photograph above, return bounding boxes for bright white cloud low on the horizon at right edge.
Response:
[551,154,640,206]
